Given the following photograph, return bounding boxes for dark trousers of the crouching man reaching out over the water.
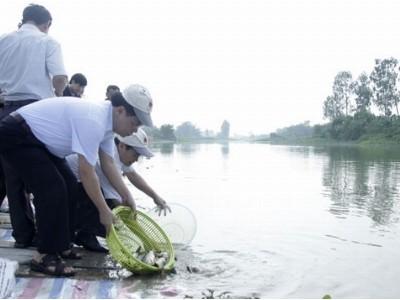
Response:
[76,183,119,237]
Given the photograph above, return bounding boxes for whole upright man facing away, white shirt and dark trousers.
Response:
[0,4,67,248]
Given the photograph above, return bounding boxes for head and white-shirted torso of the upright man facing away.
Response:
[0,4,67,115]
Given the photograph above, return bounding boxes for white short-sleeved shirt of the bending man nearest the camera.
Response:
[17,97,114,166]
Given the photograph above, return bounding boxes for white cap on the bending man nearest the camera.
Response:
[122,84,153,127]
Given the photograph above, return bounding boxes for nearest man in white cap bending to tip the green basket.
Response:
[0,85,153,276]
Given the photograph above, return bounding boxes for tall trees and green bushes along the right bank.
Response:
[270,57,400,143]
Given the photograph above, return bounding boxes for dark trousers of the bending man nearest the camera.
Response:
[0,116,77,253]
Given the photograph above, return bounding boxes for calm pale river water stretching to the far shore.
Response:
[126,143,400,298]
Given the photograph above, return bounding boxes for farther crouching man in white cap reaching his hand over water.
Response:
[66,128,170,252]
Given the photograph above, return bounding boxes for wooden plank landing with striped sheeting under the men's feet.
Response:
[0,213,248,299]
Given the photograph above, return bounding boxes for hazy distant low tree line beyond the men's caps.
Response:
[146,120,230,142]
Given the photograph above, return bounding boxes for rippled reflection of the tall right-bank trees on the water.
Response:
[318,147,400,224]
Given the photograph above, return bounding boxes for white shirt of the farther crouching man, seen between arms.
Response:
[66,143,134,201]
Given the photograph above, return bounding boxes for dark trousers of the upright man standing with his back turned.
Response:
[0,100,37,244]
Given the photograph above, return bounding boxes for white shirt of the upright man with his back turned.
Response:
[0,24,67,101]
